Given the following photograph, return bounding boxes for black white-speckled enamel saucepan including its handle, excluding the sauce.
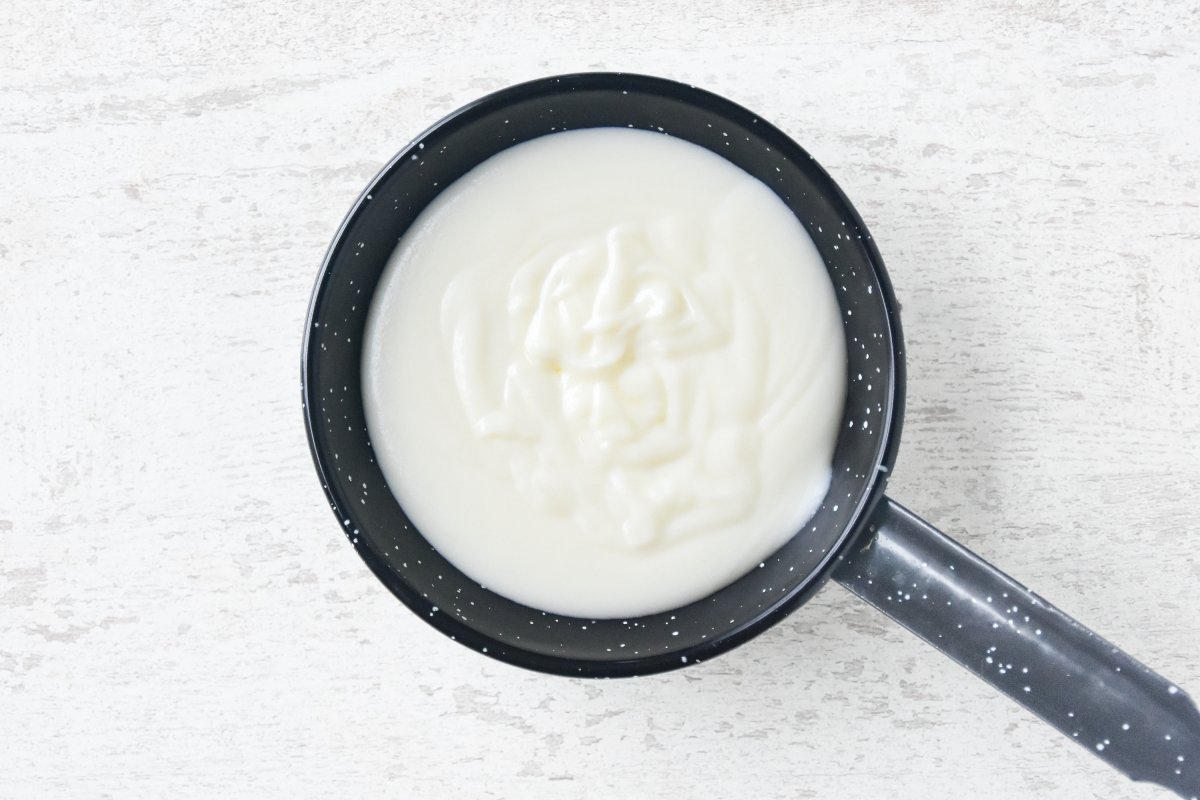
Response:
[301,73,1200,800]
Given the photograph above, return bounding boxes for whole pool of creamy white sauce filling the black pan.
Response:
[362,128,846,619]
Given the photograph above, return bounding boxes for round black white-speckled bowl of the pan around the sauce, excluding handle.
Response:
[302,73,904,676]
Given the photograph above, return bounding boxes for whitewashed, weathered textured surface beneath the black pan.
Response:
[0,0,1200,800]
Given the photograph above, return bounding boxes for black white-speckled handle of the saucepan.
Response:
[834,498,1200,800]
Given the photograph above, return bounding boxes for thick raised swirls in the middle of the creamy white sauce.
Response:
[442,219,766,548]
